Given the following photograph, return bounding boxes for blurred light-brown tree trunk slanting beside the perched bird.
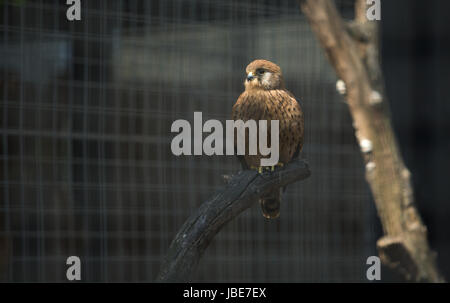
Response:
[300,0,443,282]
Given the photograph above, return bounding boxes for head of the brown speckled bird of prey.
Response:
[244,60,284,90]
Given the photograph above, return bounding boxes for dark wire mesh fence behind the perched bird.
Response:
[0,0,375,282]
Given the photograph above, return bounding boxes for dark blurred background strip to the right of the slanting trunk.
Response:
[381,0,450,281]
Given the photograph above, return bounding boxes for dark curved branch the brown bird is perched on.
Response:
[156,159,311,282]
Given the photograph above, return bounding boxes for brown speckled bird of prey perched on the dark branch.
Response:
[232,60,304,219]
